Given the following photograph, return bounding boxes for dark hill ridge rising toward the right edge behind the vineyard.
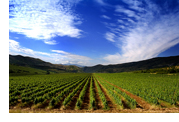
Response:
[83,56,179,73]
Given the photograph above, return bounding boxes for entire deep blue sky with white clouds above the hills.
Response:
[9,0,179,66]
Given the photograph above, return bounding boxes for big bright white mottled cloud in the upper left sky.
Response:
[9,0,82,44]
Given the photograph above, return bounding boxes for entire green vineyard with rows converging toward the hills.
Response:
[9,73,179,112]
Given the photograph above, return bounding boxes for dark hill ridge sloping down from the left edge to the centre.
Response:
[9,55,82,73]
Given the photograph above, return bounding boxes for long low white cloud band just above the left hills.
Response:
[9,40,92,66]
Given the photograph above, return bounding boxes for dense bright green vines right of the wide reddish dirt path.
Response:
[95,73,179,105]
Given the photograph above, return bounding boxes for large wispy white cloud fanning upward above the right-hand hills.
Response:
[103,0,179,64]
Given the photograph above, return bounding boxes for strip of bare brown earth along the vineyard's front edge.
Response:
[9,108,179,113]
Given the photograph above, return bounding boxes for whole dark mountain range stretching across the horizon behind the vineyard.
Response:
[9,55,179,73]
